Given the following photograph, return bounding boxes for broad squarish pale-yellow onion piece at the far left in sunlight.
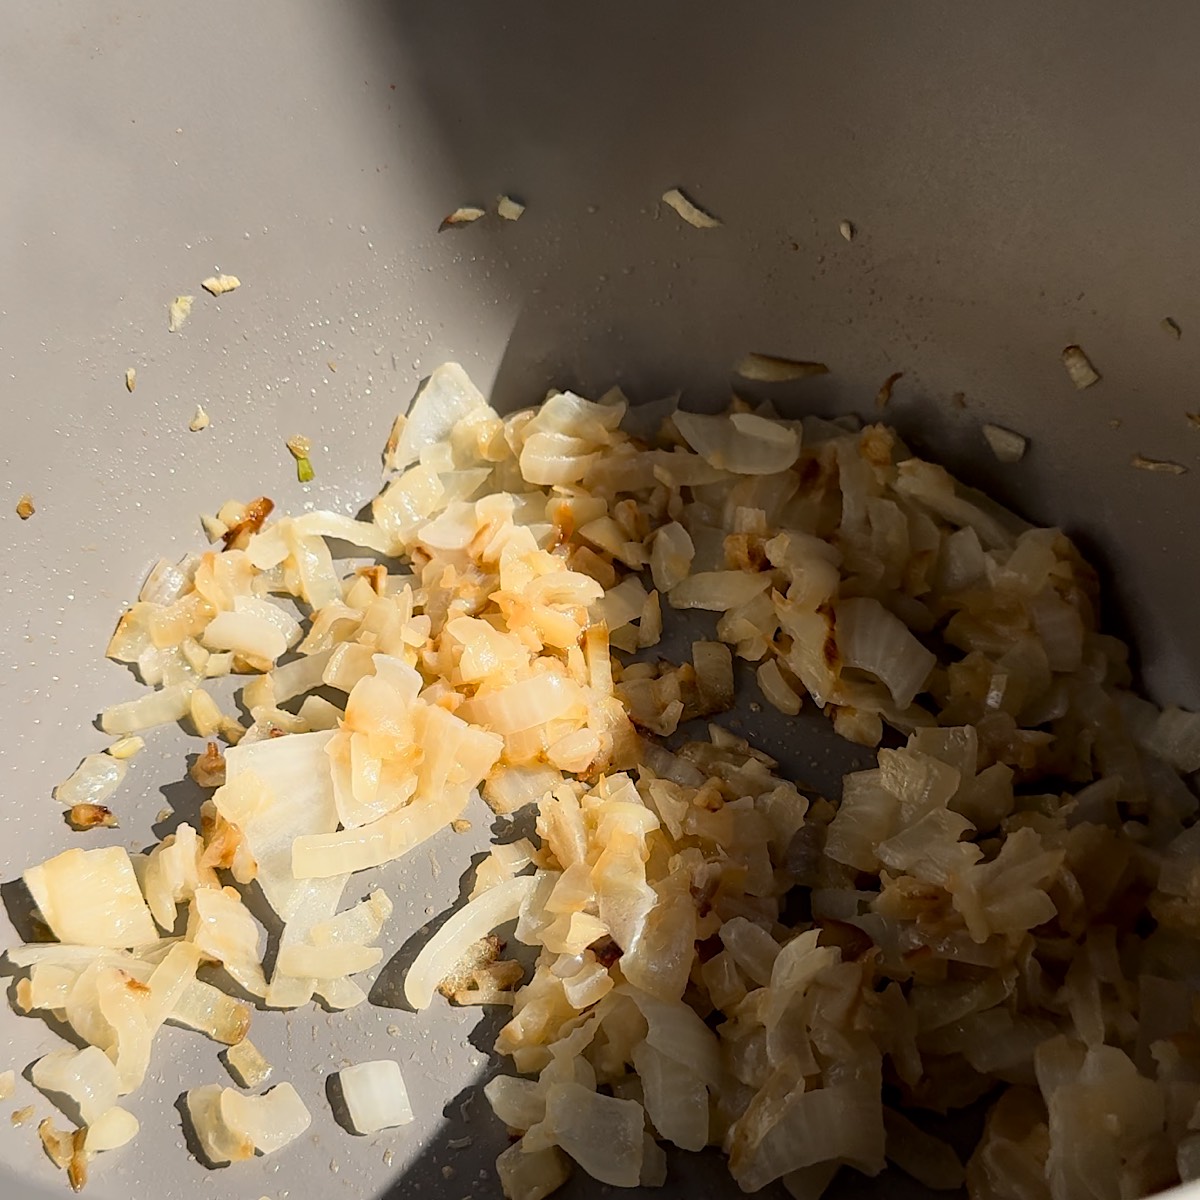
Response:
[22,846,158,949]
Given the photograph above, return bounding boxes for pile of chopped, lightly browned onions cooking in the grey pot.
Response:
[8,362,1200,1200]
